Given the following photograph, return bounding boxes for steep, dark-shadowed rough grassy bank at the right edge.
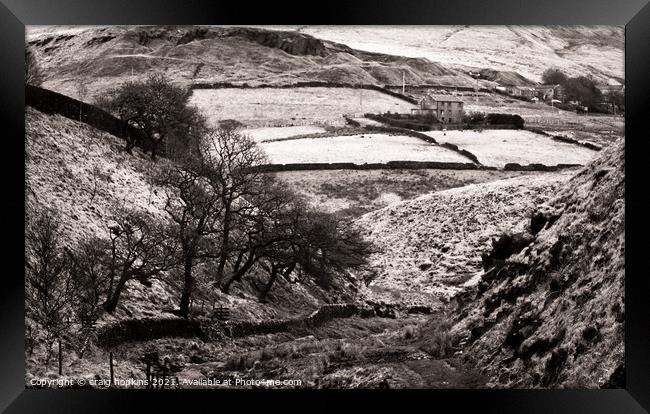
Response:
[454,140,625,388]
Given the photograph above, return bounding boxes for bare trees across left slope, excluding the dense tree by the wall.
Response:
[27,125,371,330]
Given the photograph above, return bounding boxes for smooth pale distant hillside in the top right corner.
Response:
[282,26,625,83]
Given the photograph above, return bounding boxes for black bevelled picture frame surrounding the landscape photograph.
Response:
[0,0,650,413]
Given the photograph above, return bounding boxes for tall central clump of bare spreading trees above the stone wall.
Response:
[156,129,371,316]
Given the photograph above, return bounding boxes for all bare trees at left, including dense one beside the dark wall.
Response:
[25,68,371,368]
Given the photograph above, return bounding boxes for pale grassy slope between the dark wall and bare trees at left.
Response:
[25,107,167,241]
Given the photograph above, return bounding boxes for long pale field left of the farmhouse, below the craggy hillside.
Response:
[190,87,413,128]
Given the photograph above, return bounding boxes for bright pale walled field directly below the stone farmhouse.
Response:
[425,129,596,167]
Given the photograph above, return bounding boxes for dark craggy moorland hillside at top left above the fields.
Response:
[27,26,475,97]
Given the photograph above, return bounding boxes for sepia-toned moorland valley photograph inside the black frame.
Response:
[24,25,626,390]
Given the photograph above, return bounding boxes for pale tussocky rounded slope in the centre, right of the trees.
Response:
[357,173,570,298]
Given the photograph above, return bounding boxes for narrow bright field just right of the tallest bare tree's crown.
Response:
[261,134,470,164]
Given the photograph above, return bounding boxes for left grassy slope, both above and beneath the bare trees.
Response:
[25,107,349,322]
